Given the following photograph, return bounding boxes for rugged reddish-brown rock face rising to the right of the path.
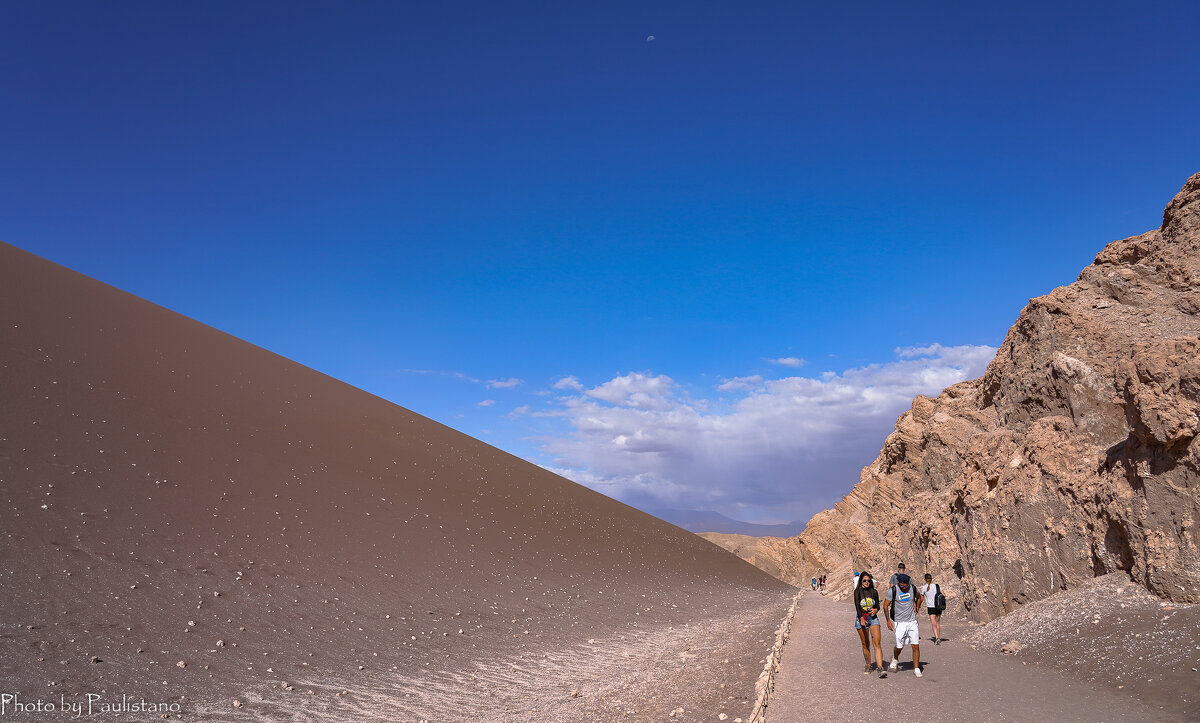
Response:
[793,174,1200,621]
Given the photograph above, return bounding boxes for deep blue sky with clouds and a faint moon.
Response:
[0,2,1200,521]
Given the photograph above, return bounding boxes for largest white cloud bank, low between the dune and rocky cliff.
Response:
[539,345,996,519]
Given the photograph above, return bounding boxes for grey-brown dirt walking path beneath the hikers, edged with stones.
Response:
[766,594,1172,723]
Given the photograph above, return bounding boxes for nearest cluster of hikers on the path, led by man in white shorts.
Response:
[854,562,946,677]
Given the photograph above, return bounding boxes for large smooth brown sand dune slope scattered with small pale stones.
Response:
[0,240,792,721]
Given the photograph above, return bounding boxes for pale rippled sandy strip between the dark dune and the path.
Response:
[197,590,779,722]
